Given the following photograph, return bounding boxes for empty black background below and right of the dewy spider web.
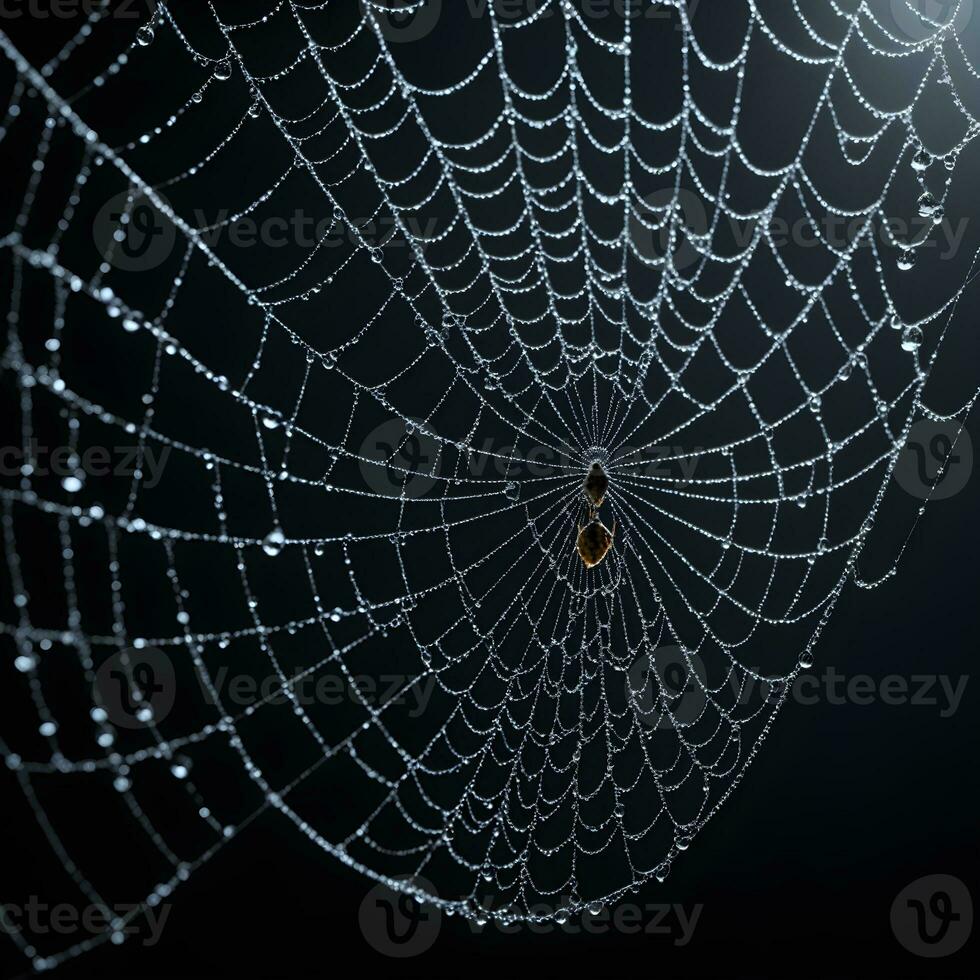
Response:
[0,5,980,977]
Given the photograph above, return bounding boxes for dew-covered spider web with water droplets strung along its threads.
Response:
[0,0,978,968]
